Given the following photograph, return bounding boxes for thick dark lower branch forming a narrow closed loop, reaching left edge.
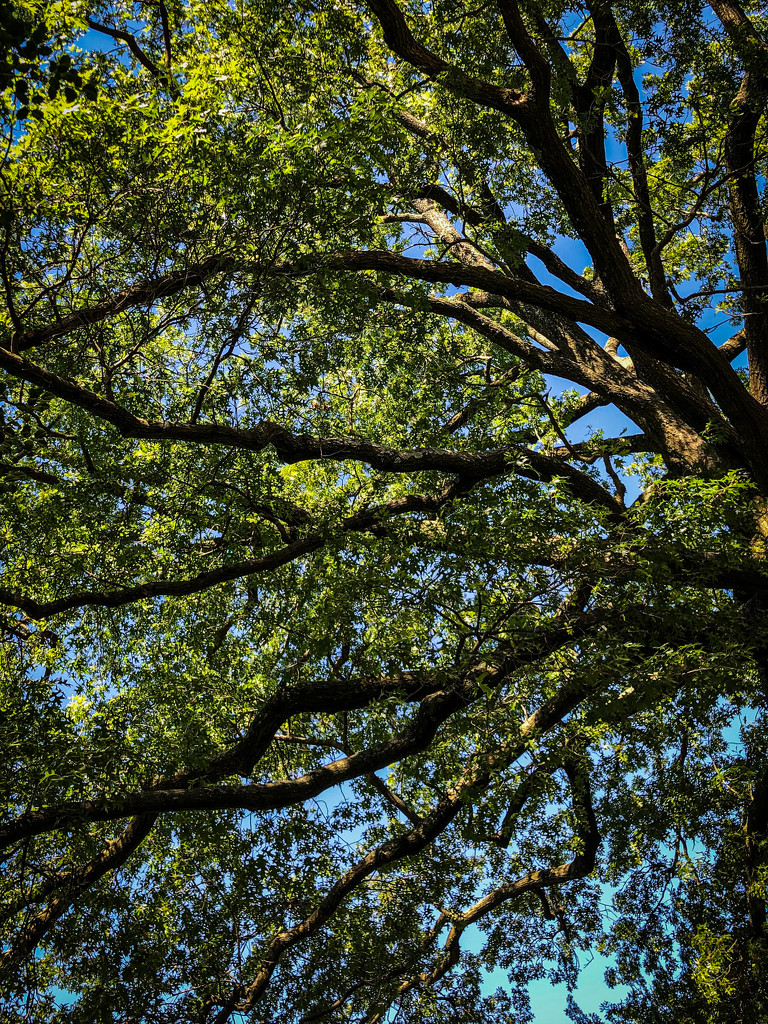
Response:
[0,609,611,848]
